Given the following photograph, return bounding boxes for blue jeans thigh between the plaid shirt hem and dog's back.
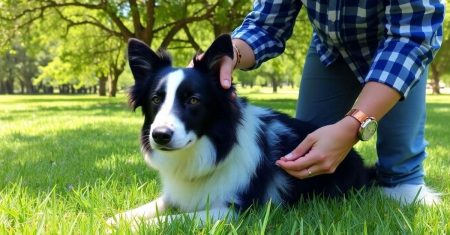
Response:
[296,47,362,126]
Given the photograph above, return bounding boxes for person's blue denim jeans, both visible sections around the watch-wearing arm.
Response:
[296,47,428,186]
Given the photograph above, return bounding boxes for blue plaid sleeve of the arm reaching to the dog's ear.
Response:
[232,0,302,69]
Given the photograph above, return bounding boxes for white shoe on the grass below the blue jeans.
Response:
[383,184,441,206]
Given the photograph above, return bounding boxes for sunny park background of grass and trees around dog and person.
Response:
[0,0,450,234]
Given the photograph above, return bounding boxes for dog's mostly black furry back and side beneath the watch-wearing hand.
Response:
[227,103,375,208]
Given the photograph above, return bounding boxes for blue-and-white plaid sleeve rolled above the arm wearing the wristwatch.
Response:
[365,0,445,98]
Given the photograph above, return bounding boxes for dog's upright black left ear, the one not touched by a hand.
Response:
[128,39,172,110]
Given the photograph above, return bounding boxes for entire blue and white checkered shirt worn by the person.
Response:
[232,0,445,98]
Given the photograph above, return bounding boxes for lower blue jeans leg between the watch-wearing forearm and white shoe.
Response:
[377,71,428,186]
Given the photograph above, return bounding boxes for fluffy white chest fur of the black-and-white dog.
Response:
[153,105,262,210]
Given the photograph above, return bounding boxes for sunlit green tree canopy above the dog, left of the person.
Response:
[0,0,251,96]
